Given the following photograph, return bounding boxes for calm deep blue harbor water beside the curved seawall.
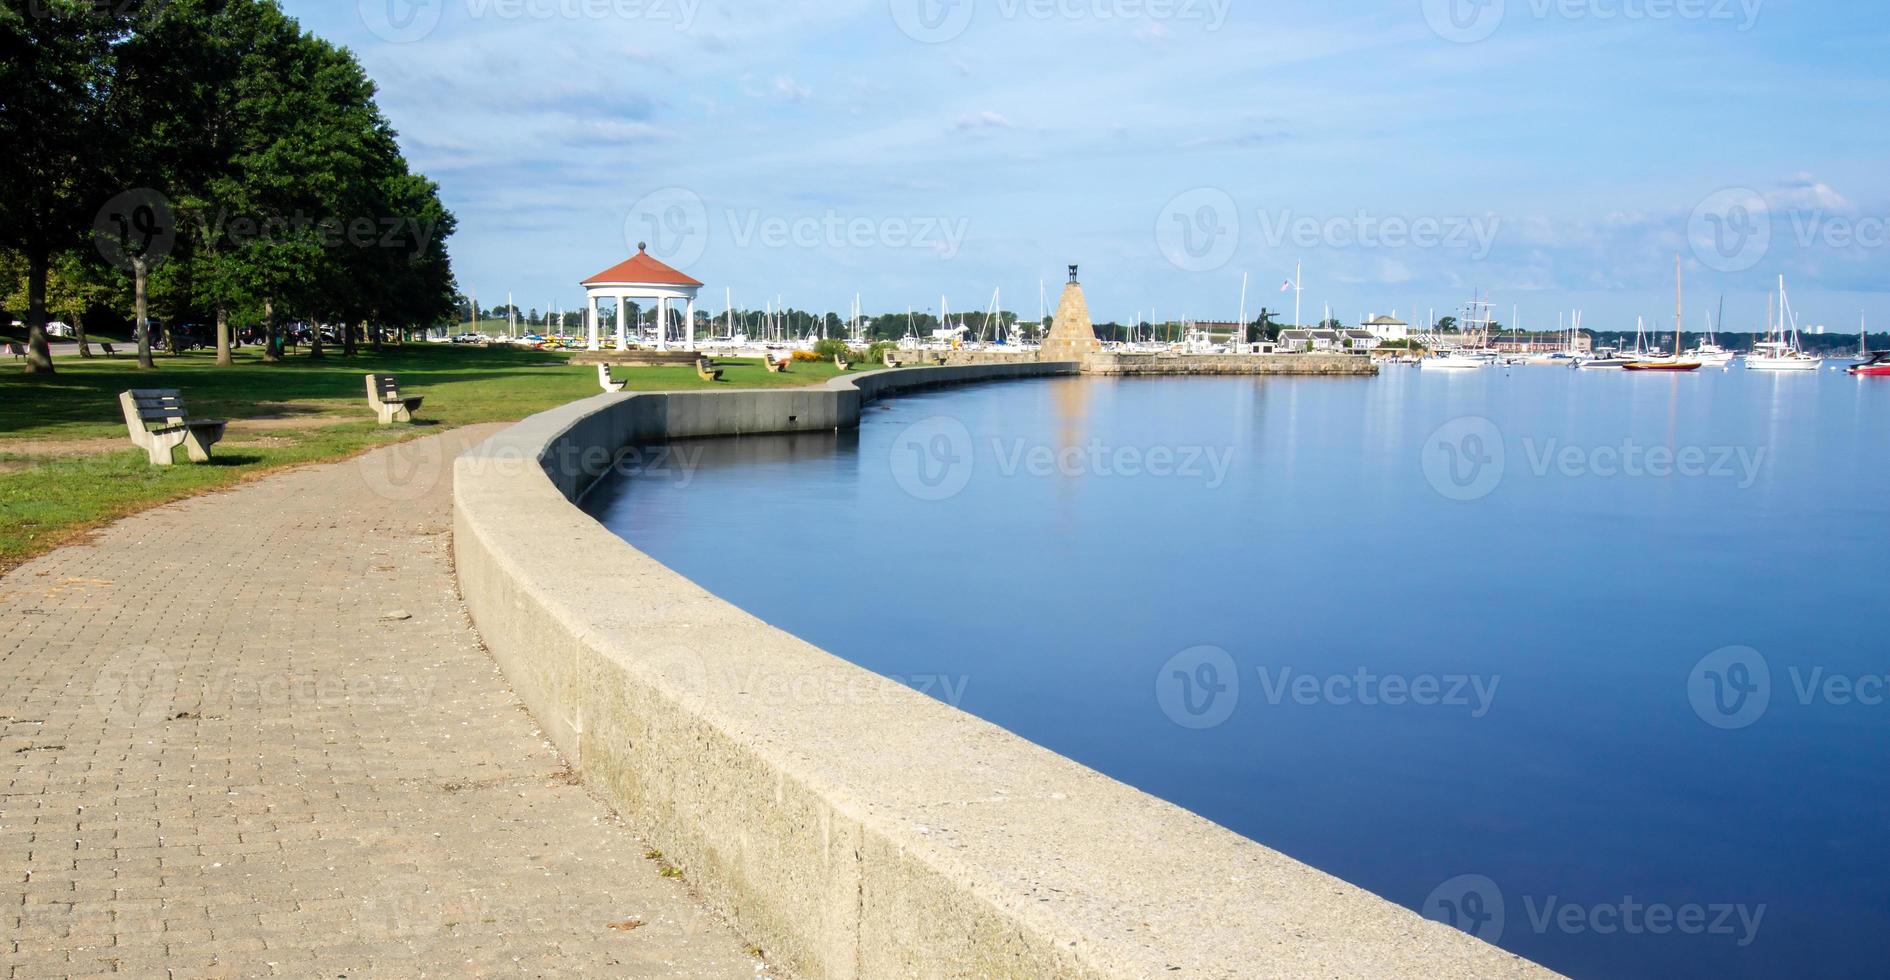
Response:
[590,368,1890,976]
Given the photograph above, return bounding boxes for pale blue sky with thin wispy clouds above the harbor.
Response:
[284,0,1890,332]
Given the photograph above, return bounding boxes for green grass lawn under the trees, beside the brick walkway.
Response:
[0,344,869,570]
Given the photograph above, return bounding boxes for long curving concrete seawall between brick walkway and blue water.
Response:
[454,363,1546,978]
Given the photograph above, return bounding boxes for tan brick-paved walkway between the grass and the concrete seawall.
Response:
[0,429,762,978]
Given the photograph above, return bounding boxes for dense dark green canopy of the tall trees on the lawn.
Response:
[0,0,455,372]
